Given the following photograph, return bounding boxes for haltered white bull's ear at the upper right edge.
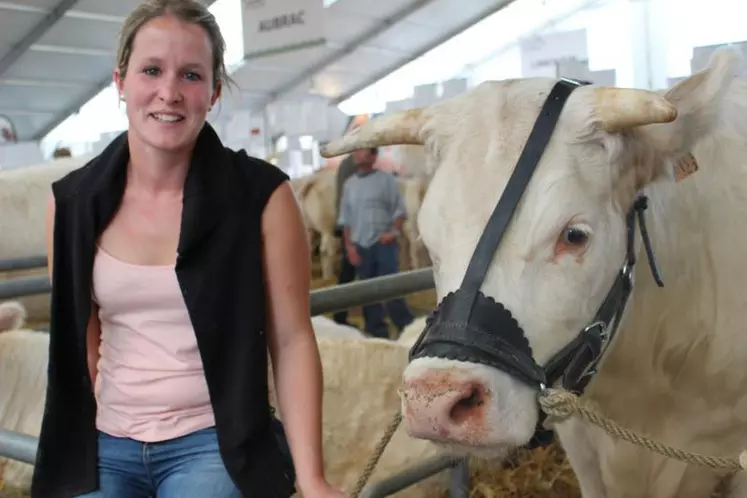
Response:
[642,47,742,161]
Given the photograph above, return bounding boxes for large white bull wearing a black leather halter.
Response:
[322,50,747,498]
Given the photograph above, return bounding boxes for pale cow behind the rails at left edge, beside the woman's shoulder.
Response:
[0,155,92,321]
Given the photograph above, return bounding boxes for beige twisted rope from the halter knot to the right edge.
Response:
[539,389,747,472]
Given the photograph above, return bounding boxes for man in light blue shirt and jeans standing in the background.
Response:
[337,148,414,338]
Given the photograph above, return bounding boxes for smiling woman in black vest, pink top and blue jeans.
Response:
[31,0,343,498]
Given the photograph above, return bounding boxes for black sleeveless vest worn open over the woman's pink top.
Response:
[31,123,293,498]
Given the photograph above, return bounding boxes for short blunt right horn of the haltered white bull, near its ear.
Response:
[595,88,677,132]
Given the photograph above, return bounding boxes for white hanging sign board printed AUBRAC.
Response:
[242,0,325,59]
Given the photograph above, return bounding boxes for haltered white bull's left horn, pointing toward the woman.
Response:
[319,108,425,157]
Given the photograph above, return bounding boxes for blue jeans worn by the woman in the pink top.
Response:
[79,428,243,498]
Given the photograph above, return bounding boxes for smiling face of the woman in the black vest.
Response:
[114,16,220,152]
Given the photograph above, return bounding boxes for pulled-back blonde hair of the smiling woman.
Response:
[117,0,233,88]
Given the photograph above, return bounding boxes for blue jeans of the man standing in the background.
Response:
[356,242,415,339]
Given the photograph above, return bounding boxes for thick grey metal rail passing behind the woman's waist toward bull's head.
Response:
[0,267,434,306]
